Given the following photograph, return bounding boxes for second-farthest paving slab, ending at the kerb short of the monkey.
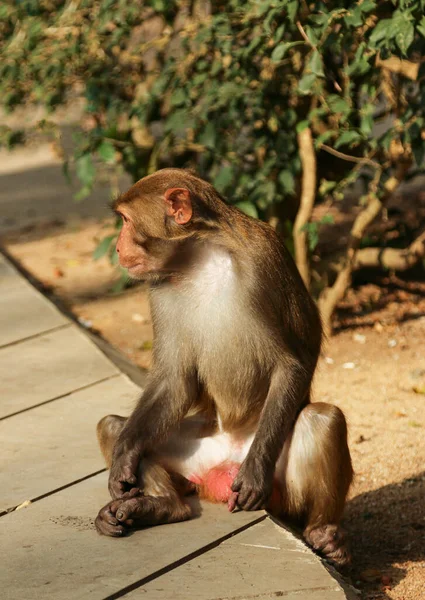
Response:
[0,325,119,418]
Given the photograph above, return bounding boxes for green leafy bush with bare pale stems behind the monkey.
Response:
[0,0,425,328]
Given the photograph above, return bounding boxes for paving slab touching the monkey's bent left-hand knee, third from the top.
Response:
[0,375,140,512]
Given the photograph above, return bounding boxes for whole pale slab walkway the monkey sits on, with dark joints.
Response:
[0,255,353,600]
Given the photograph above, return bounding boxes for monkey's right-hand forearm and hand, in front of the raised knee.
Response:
[232,357,312,510]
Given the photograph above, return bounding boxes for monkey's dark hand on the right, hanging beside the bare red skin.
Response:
[229,457,273,510]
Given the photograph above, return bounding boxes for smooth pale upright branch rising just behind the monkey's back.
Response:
[293,127,316,289]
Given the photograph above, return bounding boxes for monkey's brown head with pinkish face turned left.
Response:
[112,169,223,279]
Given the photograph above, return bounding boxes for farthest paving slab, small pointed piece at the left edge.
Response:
[0,255,69,346]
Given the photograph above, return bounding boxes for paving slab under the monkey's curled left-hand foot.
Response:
[0,473,263,600]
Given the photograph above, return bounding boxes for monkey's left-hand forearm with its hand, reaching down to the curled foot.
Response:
[109,372,197,498]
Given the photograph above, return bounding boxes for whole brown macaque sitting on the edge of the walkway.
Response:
[96,169,352,564]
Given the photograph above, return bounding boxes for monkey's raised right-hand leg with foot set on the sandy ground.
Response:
[276,402,353,565]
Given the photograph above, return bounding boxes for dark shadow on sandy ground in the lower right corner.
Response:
[344,471,425,599]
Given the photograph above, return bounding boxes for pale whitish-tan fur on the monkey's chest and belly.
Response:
[152,248,261,396]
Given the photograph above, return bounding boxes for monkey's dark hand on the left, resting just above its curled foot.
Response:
[108,443,142,498]
